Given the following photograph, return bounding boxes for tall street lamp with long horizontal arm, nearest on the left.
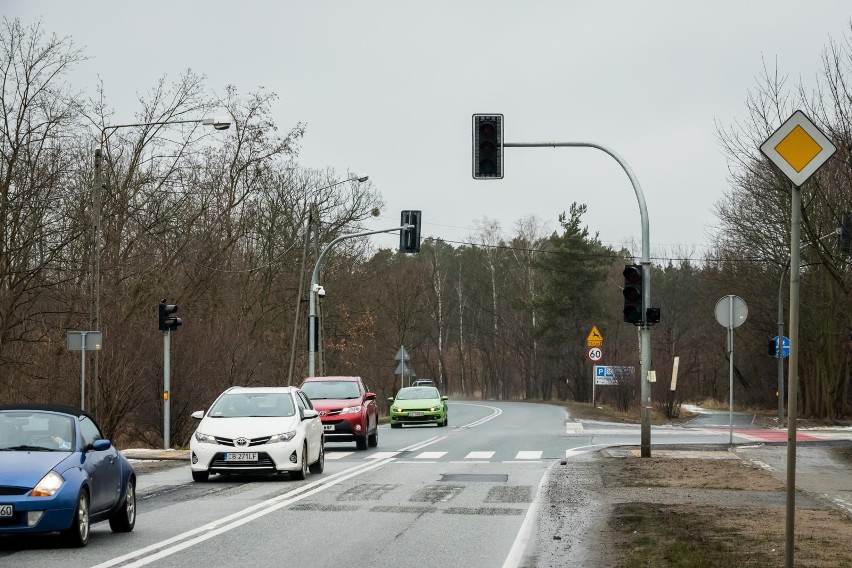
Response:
[89,117,231,413]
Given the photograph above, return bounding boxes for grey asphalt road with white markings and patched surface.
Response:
[0,401,812,568]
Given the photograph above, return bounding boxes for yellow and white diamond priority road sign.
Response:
[760,110,837,186]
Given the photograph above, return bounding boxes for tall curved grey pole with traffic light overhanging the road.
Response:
[503,142,651,458]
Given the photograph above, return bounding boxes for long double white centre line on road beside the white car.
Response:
[92,459,393,568]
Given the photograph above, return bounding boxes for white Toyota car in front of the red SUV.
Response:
[189,387,325,481]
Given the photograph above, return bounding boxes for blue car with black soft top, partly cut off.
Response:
[0,404,136,547]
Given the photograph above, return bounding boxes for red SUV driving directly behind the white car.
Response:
[300,377,379,450]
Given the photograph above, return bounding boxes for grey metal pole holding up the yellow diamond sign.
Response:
[785,184,802,568]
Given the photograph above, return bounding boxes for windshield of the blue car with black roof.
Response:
[0,410,76,452]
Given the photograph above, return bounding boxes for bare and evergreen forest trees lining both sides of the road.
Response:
[0,20,852,444]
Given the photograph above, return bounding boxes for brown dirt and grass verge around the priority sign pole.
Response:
[598,447,852,568]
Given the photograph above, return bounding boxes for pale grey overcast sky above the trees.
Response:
[6,0,852,256]
